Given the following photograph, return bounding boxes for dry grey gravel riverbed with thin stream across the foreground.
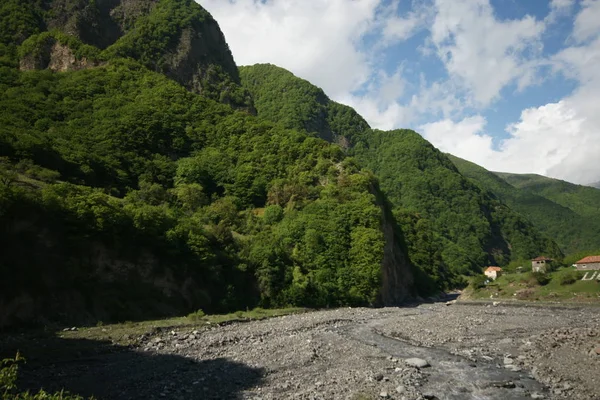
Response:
[8,303,600,400]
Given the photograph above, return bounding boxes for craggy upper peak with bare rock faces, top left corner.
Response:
[0,0,253,111]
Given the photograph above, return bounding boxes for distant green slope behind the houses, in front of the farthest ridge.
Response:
[448,155,600,254]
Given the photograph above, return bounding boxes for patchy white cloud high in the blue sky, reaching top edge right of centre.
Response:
[431,0,545,106]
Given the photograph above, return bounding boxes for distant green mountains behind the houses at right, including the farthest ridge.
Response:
[448,155,600,254]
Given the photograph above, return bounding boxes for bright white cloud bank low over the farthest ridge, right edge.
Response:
[420,99,600,184]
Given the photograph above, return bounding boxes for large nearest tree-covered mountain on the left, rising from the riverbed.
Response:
[0,0,418,327]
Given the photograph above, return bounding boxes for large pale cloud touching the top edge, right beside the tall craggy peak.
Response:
[198,0,380,97]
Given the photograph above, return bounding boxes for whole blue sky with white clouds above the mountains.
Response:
[197,0,600,184]
